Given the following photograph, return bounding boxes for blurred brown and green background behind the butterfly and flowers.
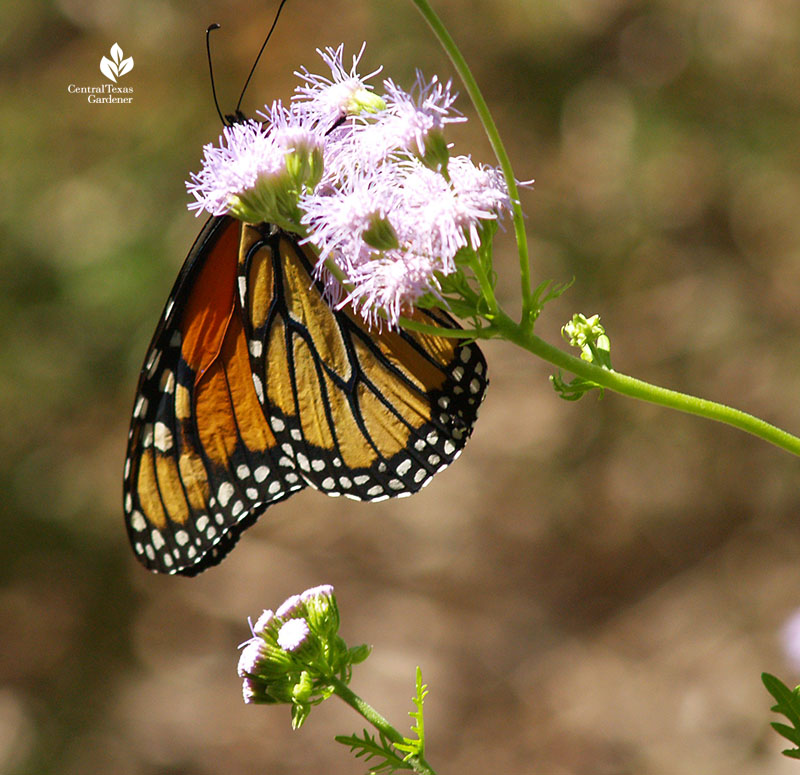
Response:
[0,0,800,775]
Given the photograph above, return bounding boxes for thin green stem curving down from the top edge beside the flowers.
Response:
[411,0,535,325]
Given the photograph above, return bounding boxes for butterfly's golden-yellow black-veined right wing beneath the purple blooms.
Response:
[239,226,487,500]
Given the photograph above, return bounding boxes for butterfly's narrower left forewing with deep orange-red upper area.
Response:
[123,217,305,575]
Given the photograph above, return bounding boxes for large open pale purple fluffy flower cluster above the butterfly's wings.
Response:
[188,46,511,326]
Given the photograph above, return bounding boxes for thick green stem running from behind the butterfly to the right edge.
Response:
[492,312,800,455]
